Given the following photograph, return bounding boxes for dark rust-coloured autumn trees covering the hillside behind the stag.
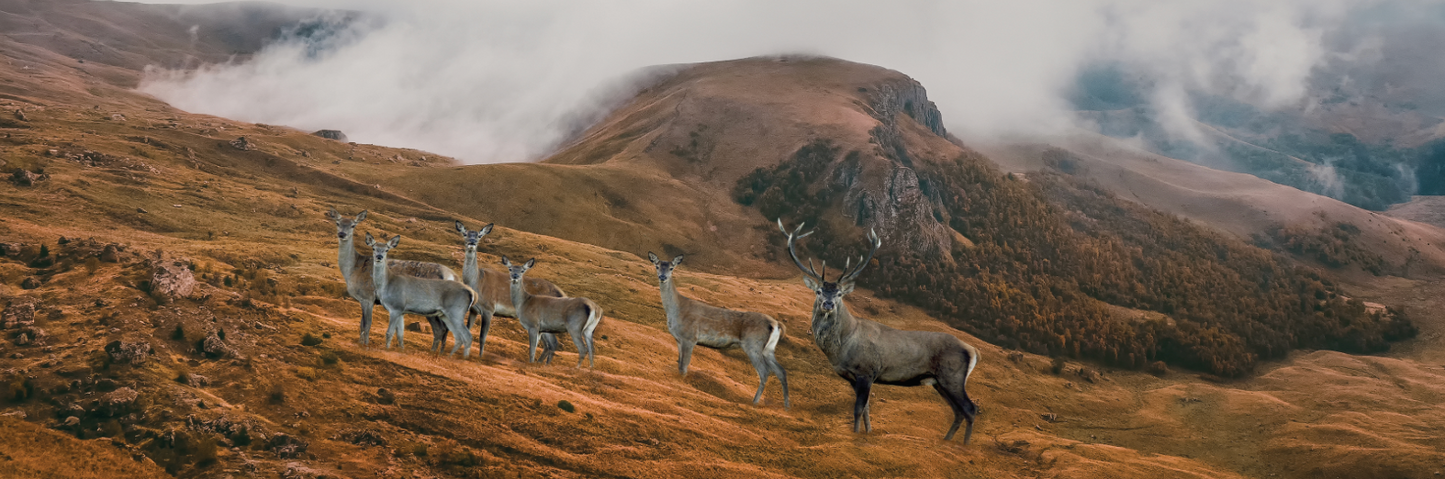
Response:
[736,143,1416,376]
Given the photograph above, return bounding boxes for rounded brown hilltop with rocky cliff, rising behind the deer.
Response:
[528,56,961,267]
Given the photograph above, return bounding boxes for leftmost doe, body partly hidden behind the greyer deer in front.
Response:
[327,208,457,350]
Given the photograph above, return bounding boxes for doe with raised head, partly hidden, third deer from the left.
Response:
[453,220,566,365]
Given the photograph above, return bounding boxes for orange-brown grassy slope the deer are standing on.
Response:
[0,3,1445,478]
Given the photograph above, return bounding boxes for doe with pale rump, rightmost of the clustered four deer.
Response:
[501,256,603,368]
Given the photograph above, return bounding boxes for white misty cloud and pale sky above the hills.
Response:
[140,0,1433,164]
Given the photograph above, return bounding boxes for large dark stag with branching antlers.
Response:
[777,219,978,444]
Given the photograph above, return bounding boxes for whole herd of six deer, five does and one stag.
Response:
[327,208,978,444]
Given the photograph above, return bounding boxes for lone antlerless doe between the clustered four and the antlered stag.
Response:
[647,252,792,410]
